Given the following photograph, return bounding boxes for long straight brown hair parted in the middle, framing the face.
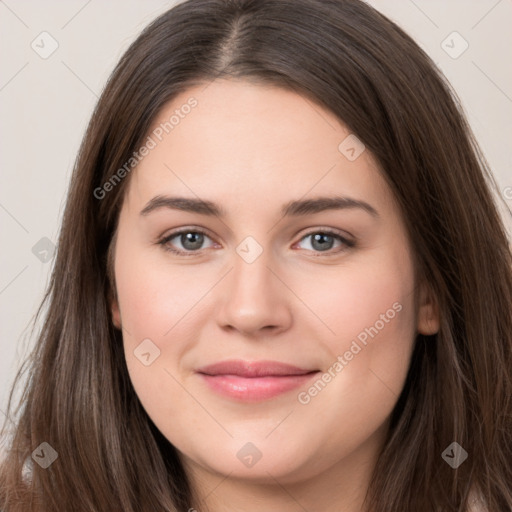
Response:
[0,0,512,512]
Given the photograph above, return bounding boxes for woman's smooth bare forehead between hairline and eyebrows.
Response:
[124,80,392,216]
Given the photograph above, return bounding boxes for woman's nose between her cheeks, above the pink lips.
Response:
[217,246,293,336]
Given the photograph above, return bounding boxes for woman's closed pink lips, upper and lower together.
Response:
[196,360,319,402]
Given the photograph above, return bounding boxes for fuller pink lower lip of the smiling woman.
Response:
[199,372,319,402]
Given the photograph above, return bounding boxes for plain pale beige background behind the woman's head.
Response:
[0,0,512,422]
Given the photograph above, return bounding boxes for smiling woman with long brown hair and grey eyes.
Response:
[0,0,512,512]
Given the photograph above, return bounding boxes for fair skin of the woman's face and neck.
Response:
[112,79,439,512]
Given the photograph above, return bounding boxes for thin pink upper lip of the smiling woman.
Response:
[196,359,317,377]
